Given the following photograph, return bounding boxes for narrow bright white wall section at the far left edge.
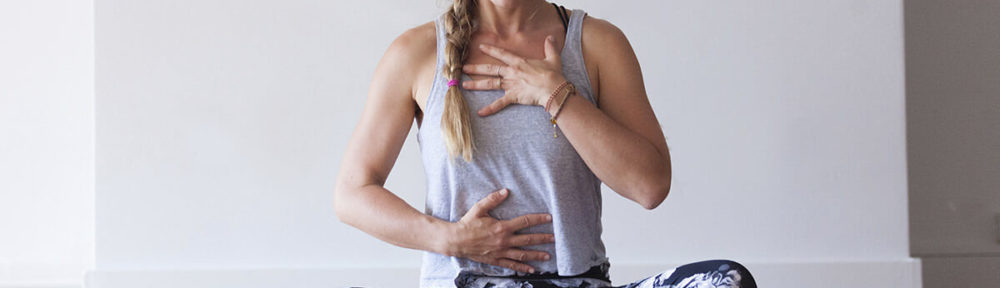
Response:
[0,0,94,287]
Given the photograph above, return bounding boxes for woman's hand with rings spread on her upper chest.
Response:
[462,36,566,116]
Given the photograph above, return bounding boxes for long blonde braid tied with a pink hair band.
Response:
[441,0,476,162]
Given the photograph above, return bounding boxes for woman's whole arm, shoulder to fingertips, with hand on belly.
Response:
[334,23,555,273]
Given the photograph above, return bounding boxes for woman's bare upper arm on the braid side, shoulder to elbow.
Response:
[337,23,436,193]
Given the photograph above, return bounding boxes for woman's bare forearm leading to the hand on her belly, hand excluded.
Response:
[334,184,449,255]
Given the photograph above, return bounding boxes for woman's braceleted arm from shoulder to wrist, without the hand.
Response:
[550,17,671,209]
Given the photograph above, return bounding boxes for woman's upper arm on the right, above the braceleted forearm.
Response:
[582,17,670,162]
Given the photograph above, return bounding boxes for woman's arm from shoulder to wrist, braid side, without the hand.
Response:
[334,24,446,254]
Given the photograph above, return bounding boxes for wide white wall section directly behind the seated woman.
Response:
[92,0,919,287]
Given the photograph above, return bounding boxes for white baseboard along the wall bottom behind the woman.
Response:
[84,258,921,288]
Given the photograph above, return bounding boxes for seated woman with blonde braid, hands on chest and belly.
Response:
[335,0,755,287]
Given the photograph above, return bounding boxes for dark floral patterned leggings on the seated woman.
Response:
[455,260,757,288]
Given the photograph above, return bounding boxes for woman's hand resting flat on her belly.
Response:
[448,188,555,273]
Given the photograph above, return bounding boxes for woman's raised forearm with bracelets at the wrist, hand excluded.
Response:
[549,94,671,209]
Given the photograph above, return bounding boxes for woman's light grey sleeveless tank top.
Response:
[417,9,610,287]
